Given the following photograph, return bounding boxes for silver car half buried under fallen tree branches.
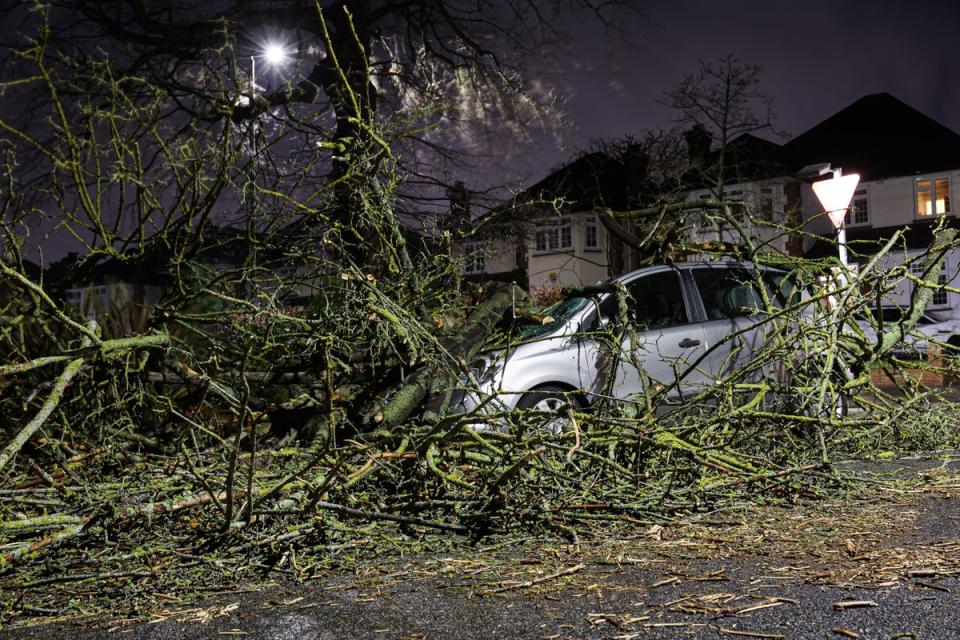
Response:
[458,262,846,430]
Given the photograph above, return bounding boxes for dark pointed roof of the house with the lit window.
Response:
[783,93,960,180]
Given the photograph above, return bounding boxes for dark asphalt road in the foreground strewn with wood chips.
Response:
[7,452,960,640]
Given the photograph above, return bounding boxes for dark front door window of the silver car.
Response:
[600,271,690,331]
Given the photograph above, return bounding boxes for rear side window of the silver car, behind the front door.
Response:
[693,268,795,320]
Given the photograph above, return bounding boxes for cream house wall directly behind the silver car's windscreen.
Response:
[527,212,610,293]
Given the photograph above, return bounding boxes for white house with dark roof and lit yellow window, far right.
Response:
[784,93,960,320]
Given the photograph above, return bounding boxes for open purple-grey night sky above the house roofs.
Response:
[521,0,960,180]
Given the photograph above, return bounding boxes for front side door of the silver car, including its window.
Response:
[585,267,712,399]
